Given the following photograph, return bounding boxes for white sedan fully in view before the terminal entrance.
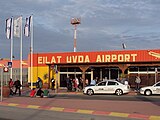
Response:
[83,80,130,96]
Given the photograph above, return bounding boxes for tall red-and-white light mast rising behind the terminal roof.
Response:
[71,18,81,52]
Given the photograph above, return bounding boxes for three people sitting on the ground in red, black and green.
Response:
[30,88,49,98]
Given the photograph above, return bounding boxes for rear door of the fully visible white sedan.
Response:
[105,81,118,93]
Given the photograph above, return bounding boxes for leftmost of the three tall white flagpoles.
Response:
[10,17,13,79]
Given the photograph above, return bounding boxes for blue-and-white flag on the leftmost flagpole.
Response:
[6,18,12,39]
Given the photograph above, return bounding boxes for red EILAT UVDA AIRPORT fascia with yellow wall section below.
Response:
[28,49,160,87]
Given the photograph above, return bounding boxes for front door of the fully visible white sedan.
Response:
[95,81,106,93]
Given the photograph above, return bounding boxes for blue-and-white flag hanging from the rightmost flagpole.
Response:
[24,16,32,37]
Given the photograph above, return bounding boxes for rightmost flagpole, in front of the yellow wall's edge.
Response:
[30,15,33,89]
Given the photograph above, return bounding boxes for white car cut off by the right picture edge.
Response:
[140,81,160,96]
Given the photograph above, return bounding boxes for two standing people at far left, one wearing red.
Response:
[8,78,22,96]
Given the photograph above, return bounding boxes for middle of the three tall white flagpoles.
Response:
[20,16,23,89]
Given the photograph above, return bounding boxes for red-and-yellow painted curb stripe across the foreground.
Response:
[0,102,160,120]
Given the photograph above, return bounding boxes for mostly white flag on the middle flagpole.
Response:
[14,17,22,37]
